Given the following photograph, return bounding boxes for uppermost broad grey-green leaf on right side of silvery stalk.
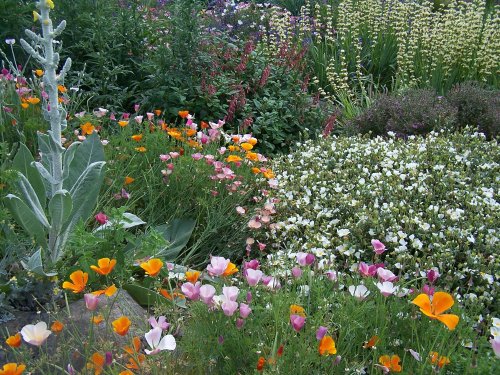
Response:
[63,133,104,191]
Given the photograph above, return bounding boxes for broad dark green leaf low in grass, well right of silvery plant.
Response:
[155,219,196,261]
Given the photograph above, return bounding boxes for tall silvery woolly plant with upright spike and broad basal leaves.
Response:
[5,0,105,274]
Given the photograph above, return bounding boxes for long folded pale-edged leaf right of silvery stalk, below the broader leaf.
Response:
[50,161,106,262]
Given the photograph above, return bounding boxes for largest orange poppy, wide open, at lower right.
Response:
[411,292,460,331]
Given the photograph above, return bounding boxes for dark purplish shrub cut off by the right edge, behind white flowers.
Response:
[447,82,500,138]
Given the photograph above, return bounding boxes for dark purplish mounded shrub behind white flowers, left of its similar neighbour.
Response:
[349,89,457,136]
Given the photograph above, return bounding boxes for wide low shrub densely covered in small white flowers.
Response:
[269,133,500,305]
